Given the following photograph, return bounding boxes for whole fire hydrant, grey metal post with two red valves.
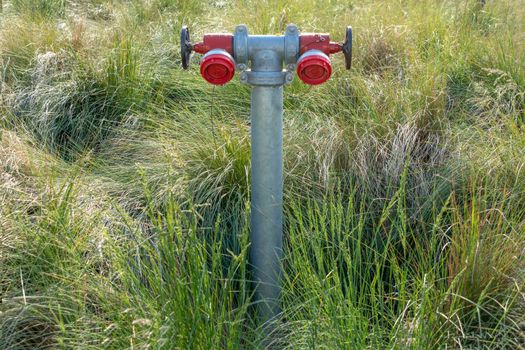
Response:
[181,24,352,321]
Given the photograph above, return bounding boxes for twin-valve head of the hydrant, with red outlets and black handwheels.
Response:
[181,25,352,85]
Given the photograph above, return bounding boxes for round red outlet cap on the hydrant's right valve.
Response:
[297,50,332,85]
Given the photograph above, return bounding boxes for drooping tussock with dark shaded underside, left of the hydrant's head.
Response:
[7,32,150,159]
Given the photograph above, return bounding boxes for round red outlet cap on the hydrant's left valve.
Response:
[201,50,235,85]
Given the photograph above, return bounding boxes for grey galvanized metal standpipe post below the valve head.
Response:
[250,86,283,321]
